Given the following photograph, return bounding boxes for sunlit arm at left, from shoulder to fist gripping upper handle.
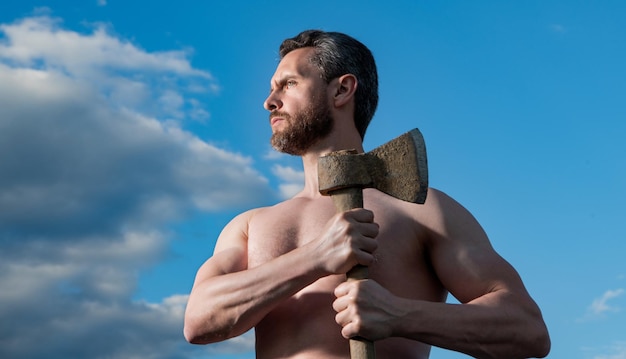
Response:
[184,210,378,344]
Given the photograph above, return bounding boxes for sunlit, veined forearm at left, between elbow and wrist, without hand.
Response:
[185,248,326,344]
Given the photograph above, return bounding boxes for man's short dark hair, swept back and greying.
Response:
[279,30,378,139]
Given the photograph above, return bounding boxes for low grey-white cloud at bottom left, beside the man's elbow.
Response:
[0,233,183,358]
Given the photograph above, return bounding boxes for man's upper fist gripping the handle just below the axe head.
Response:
[310,208,379,274]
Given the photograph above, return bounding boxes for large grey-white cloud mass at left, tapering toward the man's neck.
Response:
[0,17,268,238]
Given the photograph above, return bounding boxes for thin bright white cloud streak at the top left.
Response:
[0,16,212,80]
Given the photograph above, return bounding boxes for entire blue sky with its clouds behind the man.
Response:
[0,0,626,359]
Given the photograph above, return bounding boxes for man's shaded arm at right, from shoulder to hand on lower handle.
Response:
[335,190,550,358]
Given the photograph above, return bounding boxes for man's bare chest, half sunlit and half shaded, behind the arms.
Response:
[248,194,443,319]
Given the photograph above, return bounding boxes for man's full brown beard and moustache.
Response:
[270,101,334,156]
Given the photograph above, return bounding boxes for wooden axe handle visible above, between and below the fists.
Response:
[330,187,376,359]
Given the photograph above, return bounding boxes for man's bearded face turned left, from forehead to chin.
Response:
[265,48,334,156]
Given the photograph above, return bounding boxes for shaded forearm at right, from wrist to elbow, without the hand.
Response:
[393,292,550,358]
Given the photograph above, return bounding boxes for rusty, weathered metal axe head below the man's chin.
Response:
[318,129,428,203]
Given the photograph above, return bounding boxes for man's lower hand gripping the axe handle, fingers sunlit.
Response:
[333,279,402,341]
